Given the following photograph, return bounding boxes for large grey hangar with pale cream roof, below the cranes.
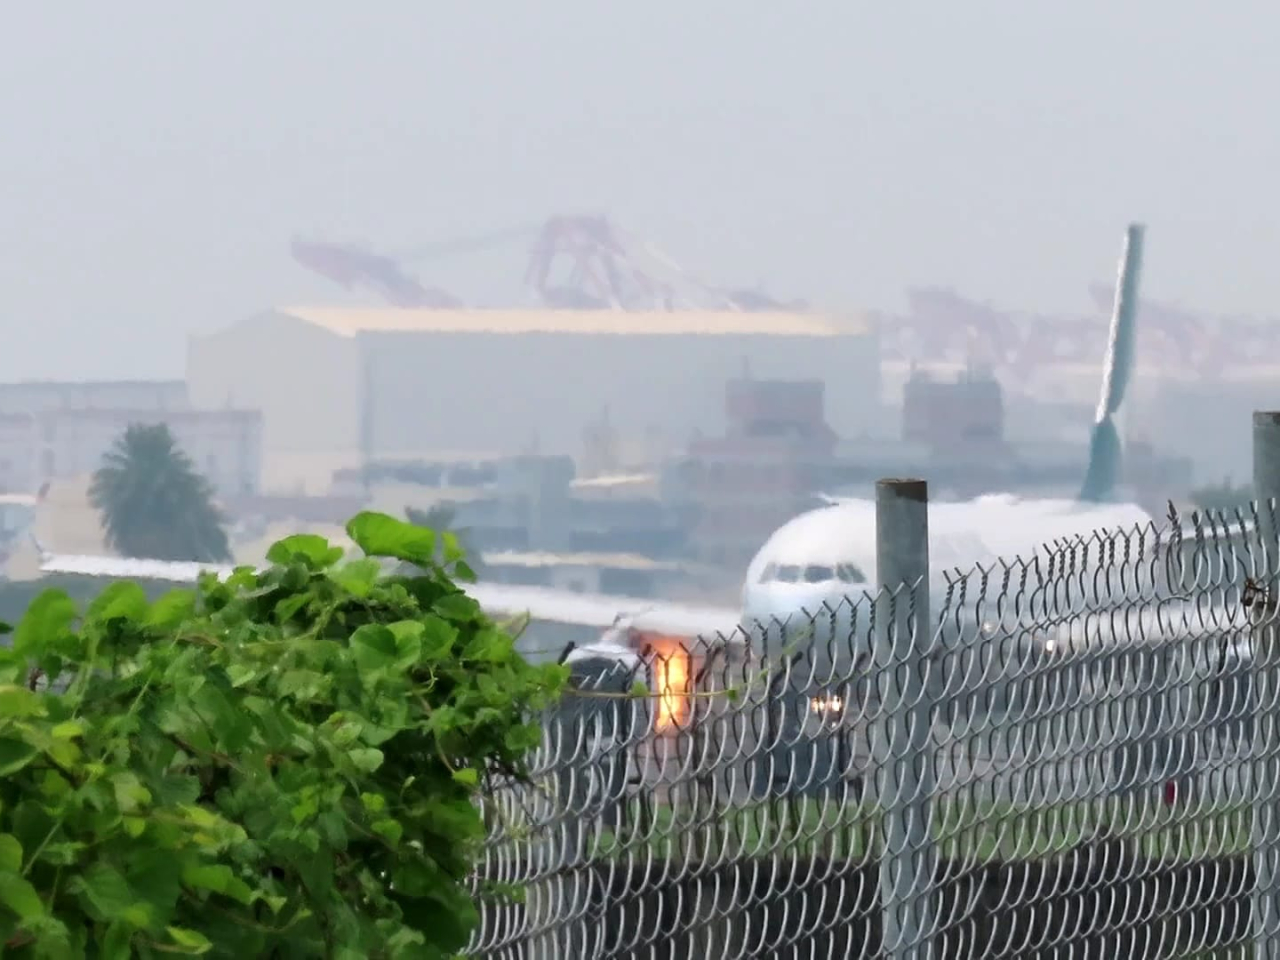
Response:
[187,307,881,492]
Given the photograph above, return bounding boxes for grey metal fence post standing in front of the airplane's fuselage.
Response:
[874,480,936,960]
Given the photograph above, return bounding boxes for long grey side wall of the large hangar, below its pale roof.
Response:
[358,333,879,456]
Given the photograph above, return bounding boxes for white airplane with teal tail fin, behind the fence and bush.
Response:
[27,223,1153,670]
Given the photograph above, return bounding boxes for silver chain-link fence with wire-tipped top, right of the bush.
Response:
[455,496,1280,960]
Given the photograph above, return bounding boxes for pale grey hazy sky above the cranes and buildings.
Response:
[0,0,1280,379]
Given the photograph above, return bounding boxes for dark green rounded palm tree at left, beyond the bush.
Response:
[88,424,232,563]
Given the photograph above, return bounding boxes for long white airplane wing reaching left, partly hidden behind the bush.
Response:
[40,554,740,639]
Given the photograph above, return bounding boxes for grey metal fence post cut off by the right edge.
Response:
[1249,411,1280,960]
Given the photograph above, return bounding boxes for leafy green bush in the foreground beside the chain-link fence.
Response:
[0,513,566,960]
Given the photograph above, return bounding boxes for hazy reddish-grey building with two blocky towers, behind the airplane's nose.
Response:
[664,371,1190,571]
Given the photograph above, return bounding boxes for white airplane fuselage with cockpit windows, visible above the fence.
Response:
[742,494,1153,639]
